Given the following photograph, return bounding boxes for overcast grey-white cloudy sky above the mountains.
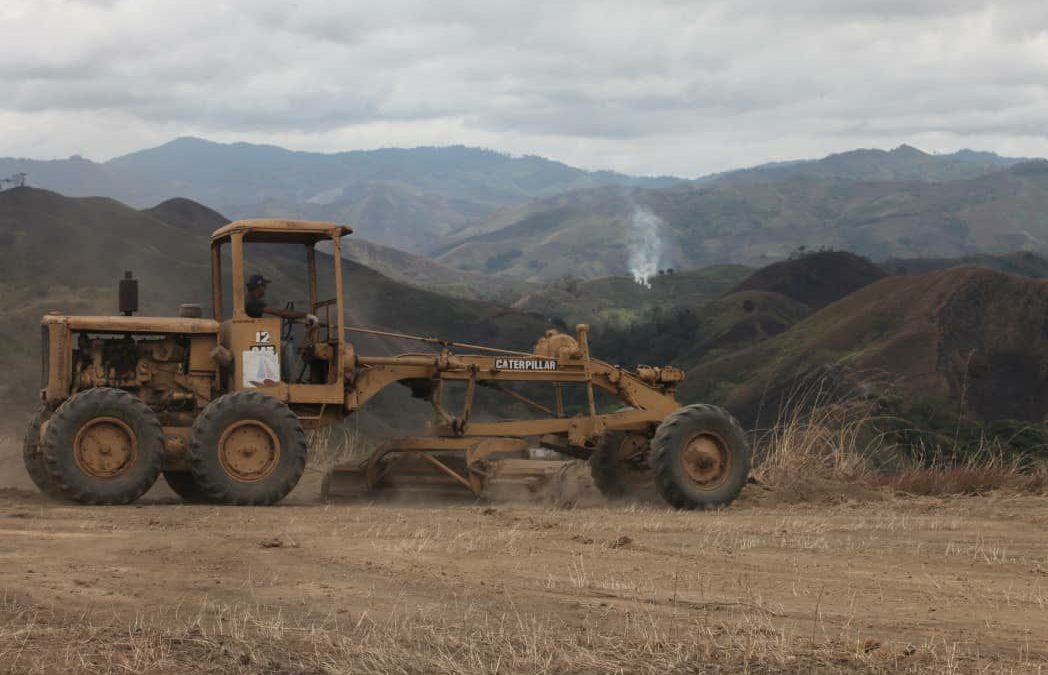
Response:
[0,0,1048,176]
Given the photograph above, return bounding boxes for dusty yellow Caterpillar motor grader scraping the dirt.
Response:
[24,219,750,508]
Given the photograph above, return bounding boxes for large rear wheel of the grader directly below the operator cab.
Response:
[190,391,307,505]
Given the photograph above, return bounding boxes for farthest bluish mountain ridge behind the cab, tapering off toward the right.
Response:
[0,137,677,252]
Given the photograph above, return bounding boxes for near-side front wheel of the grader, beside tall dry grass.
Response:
[652,405,751,508]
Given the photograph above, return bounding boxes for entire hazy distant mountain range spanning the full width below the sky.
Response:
[6,137,1048,280]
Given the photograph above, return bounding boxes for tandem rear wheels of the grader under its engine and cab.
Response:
[22,387,306,504]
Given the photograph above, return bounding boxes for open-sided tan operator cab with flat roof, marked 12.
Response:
[211,219,352,404]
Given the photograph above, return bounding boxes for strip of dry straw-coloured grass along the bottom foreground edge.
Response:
[0,597,1018,675]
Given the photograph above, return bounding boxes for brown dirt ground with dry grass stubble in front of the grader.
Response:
[0,431,1048,673]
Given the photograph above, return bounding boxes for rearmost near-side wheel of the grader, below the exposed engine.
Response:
[40,387,163,504]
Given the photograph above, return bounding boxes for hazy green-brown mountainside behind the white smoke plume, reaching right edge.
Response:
[438,160,1048,281]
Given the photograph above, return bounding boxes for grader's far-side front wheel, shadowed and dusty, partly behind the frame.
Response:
[590,431,655,500]
